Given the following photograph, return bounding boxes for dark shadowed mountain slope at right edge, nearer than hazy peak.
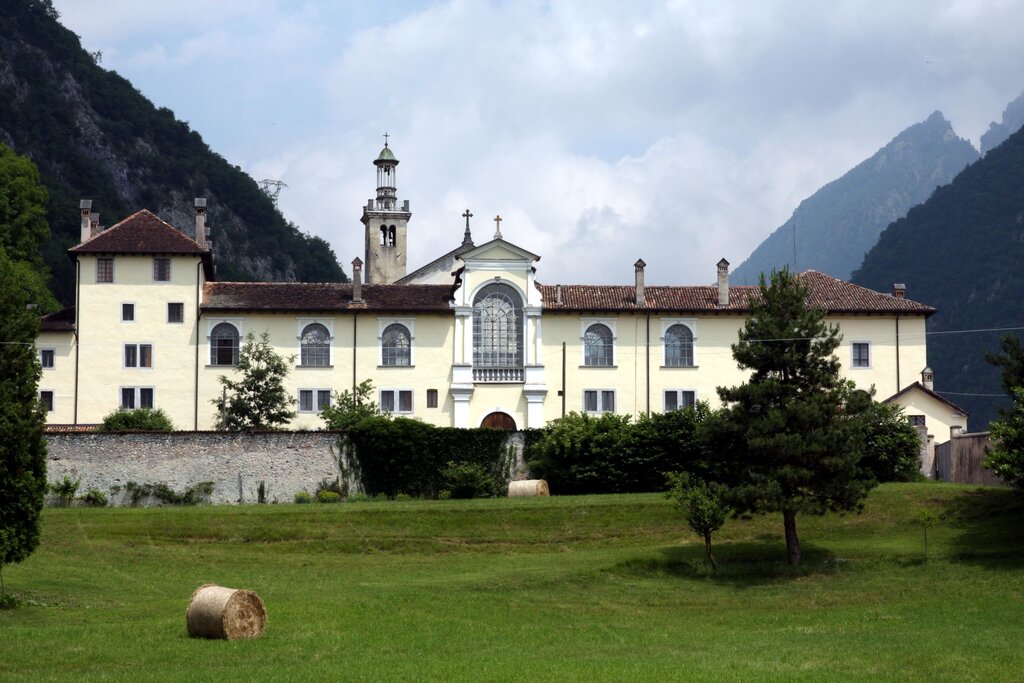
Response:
[853,124,1024,429]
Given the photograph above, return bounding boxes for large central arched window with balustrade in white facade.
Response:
[473,283,523,381]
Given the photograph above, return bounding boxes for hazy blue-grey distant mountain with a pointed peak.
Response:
[733,112,978,285]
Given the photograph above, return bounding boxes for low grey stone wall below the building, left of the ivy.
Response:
[46,432,340,505]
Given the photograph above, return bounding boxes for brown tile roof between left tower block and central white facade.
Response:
[202,283,453,312]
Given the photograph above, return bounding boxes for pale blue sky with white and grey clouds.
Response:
[54,0,1024,284]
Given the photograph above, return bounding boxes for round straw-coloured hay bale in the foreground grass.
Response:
[185,584,266,640]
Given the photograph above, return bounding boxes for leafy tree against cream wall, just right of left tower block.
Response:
[212,332,295,431]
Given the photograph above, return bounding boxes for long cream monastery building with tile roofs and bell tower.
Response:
[38,144,935,430]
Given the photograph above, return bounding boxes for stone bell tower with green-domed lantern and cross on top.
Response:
[361,133,413,285]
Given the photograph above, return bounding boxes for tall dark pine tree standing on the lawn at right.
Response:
[711,269,874,565]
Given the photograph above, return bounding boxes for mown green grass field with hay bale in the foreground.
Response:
[0,484,1024,681]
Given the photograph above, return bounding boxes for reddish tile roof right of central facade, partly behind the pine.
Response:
[538,270,935,315]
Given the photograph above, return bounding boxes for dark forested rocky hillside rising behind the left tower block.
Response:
[0,0,347,304]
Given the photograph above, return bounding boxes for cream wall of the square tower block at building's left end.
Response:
[78,255,202,429]
